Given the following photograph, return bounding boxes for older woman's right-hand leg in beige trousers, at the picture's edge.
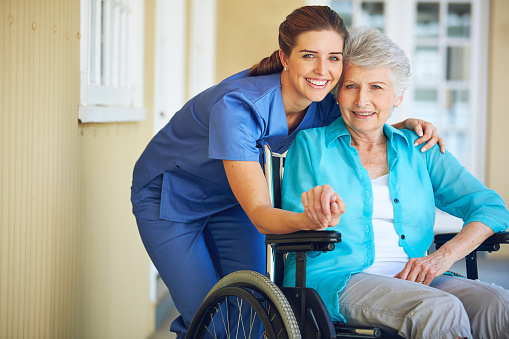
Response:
[431,276,509,339]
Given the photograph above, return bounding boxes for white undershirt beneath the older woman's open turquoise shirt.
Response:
[364,174,409,277]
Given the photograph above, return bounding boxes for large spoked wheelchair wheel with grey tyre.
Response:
[186,271,301,339]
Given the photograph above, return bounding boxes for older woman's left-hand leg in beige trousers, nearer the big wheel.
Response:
[338,273,472,339]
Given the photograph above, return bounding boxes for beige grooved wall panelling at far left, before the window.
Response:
[0,0,83,338]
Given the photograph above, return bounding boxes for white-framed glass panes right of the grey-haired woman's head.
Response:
[413,1,481,171]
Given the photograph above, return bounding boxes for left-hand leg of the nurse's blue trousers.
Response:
[132,178,219,338]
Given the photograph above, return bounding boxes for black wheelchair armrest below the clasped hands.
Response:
[265,231,341,252]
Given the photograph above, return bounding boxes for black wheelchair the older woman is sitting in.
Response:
[186,146,509,339]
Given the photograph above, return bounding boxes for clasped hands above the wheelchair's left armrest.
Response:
[301,185,346,229]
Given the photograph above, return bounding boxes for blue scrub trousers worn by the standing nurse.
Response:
[131,176,266,338]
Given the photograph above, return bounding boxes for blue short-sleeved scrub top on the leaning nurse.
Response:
[132,70,341,222]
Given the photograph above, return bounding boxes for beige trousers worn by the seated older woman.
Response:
[339,273,509,339]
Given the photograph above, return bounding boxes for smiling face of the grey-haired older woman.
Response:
[338,64,402,133]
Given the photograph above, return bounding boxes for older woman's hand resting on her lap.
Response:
[394,251,455,286]
